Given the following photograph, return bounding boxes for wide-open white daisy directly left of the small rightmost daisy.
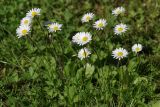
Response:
[112,48,128,60]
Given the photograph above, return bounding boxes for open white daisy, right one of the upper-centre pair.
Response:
[93,19,107,30]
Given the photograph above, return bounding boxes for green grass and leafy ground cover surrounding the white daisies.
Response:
[0,0,160,107]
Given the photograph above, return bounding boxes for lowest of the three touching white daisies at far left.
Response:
[16,25,30,38]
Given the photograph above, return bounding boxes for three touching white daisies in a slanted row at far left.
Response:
[16,8,41,38]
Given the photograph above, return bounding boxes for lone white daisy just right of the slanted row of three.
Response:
[48,23,62,32]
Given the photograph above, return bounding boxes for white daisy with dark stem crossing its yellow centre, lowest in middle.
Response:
[78,48,91,60]
